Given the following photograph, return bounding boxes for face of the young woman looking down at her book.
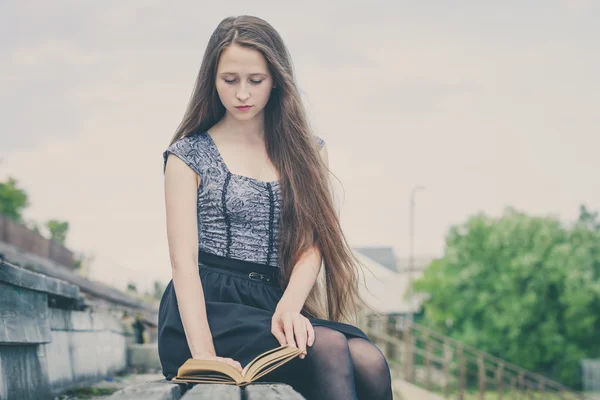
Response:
[216,44,273,120]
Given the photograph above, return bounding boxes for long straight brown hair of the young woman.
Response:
[166,15,362,322]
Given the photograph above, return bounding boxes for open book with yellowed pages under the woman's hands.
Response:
[171,345,302,386]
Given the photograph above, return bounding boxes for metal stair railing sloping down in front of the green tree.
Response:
[359,313,588,400]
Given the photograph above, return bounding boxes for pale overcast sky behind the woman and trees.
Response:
[0,0,600,287]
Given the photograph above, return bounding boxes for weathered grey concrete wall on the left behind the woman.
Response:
[0,262,129,400]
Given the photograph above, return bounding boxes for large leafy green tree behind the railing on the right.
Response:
[415,206,600,387]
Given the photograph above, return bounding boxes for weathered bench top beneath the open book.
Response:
[108,379,304,400]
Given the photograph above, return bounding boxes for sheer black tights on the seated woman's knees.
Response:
[302,326,392,400]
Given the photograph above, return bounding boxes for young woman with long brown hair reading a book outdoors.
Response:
[158,16,392,400]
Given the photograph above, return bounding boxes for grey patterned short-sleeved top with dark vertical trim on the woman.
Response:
[163,131,325,267]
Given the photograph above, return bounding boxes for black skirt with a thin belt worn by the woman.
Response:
[158,251,368,386]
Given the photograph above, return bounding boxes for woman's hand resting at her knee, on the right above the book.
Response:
[271,308,315,359]
